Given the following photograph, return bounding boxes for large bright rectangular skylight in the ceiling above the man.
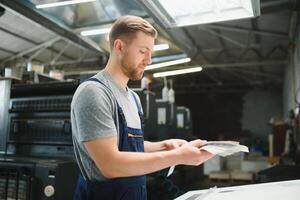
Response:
[140,0,260,27]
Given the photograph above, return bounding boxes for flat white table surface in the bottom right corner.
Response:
[175,180,300,200]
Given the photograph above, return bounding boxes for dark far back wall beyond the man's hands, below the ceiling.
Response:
[176,89,283,140]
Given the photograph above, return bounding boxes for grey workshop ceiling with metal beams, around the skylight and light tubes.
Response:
[0,0,299,91]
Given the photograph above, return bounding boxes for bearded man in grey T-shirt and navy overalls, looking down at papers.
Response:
[71,16,213,200]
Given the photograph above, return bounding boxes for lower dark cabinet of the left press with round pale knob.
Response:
[0,155,78,200]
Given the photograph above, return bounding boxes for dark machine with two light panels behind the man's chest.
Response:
[133,88,192,141]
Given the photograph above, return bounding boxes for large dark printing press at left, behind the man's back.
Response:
[0,79,79,200]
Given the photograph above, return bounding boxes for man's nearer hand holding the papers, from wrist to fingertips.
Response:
[176,139,214,165]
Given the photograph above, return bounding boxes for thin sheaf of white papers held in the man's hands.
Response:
[200,141,249,157]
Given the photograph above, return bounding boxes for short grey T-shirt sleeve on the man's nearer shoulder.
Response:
[72,84,117,142]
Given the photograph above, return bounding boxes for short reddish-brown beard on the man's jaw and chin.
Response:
[121,57,144,81]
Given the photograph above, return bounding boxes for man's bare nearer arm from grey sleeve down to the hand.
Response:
[84,137,212,178]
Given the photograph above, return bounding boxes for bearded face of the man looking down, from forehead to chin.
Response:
[120,32,154,80]
